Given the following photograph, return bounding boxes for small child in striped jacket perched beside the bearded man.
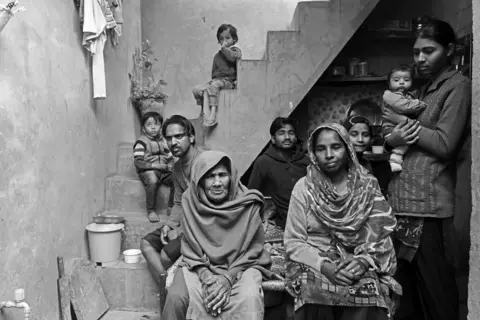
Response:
[133,112,173,222]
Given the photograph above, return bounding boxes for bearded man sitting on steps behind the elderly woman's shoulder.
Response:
[140,115,201,283]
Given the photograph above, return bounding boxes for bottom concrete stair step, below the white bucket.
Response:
[95,257,160,312]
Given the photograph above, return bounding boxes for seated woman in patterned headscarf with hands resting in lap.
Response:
[284,124,401,320]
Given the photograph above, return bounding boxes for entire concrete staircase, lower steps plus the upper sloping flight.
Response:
[87,0,379,320]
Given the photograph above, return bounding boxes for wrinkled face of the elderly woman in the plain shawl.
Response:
[200,163,231,204]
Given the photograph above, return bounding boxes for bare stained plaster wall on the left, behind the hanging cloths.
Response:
[0,0,141,320]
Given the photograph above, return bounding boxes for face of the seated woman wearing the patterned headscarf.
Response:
[314,129,348,174]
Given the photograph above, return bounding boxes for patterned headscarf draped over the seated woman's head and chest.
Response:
[306,123,378,232]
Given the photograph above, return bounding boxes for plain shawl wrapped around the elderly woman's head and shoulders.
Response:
[181,151,271,274]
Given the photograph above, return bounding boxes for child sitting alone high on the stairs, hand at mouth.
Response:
[193,24,242,127]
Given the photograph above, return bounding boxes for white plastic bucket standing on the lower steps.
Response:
[86,223,124,262]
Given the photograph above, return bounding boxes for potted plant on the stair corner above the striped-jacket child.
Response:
[129,40,168,116]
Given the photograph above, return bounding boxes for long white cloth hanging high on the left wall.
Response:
[82,0,107,99]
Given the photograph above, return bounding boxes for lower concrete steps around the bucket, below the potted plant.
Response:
[88,143,165,320]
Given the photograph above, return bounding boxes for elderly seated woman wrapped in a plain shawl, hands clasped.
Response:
[162,151,272,320]
